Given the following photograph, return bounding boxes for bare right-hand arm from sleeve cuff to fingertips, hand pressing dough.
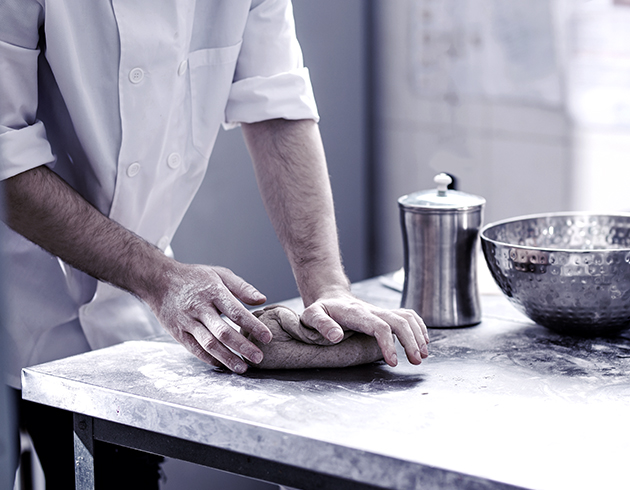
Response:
[243,120,428,366]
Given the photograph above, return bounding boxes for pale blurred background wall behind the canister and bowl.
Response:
[372,0,630,273]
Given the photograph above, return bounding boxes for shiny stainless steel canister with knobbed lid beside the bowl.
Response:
[398,174,486,327]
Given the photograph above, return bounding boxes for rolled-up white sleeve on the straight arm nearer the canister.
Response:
[224,0,319,128]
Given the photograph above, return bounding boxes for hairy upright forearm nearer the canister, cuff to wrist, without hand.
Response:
[243,119,349,305]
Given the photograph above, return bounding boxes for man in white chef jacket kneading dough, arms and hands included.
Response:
[0,0,428,486]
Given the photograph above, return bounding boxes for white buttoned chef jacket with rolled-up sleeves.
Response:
[0,0,318,386]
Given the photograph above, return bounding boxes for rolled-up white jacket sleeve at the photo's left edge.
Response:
[0,0,54,180]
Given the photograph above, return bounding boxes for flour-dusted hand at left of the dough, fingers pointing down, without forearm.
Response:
[150,261,272,374]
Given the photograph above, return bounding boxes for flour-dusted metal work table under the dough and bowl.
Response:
[23,279,630,490]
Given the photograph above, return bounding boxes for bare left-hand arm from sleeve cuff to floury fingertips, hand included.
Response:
[3,166,271,373]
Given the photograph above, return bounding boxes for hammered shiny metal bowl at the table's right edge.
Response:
[481,213,630,336]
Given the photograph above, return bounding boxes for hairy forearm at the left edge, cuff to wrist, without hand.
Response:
[4,167,169,297]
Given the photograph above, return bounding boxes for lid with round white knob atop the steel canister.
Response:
[398,173,486,212]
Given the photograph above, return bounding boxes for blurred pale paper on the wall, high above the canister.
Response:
[408,0,562,106]
